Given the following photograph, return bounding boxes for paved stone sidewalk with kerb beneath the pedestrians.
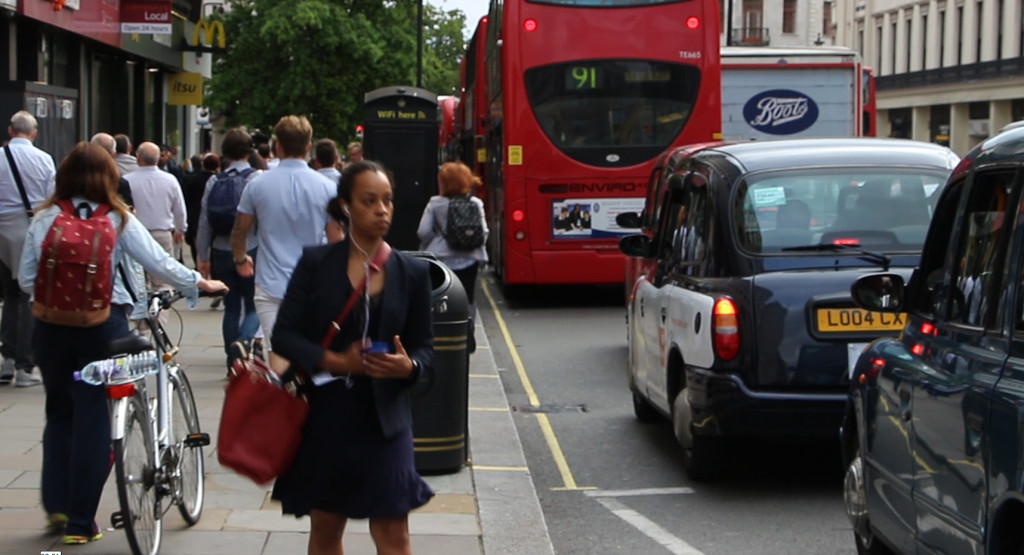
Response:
[0,300,553,555]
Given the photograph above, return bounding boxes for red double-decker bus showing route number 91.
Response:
[485,0,722,286]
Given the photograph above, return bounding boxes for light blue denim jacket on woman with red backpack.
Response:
[17,196,202,307]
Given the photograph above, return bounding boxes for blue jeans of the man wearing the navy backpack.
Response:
[210,249,259,362]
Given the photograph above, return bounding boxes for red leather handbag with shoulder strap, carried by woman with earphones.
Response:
[217,243,391,484]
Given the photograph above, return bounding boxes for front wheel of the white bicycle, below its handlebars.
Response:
[168,368,205,526]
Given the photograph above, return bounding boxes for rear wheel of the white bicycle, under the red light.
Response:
[114,396,162,555]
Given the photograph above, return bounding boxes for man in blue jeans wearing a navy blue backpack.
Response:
[196,127,260,371]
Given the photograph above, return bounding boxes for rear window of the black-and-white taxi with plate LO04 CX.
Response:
[733,168,947,256]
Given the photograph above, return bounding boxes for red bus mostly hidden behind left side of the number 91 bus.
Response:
[457,16,488,200]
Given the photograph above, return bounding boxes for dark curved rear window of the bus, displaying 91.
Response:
[525,59,700,166]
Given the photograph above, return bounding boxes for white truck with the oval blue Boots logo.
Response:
[721,46,867,140]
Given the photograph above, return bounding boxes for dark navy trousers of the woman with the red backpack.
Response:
[33,305,128,536]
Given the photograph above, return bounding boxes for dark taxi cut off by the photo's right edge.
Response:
[842,127,1024,555]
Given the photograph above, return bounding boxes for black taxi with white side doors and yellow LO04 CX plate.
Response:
[618,138,958,479]
